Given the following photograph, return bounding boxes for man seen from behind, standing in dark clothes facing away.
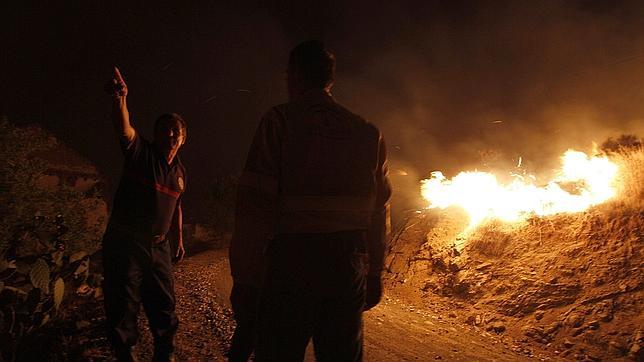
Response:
[230,41,391,361]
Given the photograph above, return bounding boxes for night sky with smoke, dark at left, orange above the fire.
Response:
[0,1,644,218]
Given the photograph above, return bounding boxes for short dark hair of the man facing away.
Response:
[288,40,335,88]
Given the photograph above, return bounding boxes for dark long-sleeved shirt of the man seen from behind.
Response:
[230,90,391,284]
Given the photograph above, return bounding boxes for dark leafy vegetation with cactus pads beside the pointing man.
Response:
[0,119,105,360]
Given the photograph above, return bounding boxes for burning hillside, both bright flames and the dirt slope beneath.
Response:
[387,147,644,359]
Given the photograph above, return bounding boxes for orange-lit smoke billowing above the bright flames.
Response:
[270,1,644,215]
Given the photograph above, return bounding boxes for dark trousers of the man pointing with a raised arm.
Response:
[103,232,179,360]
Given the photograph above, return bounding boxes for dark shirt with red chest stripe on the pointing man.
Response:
[108,131,186,241]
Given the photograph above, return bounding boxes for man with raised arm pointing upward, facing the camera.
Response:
[103,68,186,361]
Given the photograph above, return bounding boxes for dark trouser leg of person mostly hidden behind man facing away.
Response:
[228,283,259,362]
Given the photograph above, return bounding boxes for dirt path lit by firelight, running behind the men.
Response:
[128,250,528,361]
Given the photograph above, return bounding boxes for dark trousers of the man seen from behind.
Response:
[256,231,368,362]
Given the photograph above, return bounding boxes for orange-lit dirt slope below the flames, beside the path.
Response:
[387,151,644,360]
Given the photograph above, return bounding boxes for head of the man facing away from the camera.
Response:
[286,40,335,98]
